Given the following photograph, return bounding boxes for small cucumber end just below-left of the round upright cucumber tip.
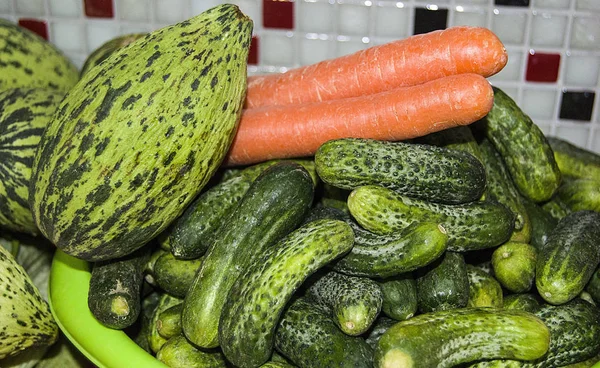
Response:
[467,264,503,308]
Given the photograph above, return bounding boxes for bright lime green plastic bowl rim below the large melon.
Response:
[50,250,166,368]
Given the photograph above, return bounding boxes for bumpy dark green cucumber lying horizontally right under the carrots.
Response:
[315,138,485,204]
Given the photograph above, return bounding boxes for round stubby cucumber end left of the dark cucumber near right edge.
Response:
[492,242,538,293]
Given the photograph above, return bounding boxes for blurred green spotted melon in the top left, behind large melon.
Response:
[0,19,79,93]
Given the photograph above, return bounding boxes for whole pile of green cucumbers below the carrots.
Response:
[89,84,600,367]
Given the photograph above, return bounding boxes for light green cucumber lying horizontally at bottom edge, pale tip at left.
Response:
[374,307,550,368]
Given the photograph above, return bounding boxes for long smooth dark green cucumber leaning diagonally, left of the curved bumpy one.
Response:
[183,162,314,348]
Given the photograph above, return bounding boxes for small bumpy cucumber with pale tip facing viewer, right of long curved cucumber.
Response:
[305,271,383,336]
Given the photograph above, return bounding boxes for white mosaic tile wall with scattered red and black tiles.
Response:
[0,0,600,153]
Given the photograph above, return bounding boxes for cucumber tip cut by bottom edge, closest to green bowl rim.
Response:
[156,335,227,368]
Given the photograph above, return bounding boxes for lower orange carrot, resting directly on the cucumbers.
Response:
[225,74,494,166]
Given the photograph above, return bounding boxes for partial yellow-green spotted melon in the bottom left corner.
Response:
[0,246,58,359]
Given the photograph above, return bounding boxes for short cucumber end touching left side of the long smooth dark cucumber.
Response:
[152,252,203,298]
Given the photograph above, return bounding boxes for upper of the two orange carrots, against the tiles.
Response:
[245,26,508,108]
